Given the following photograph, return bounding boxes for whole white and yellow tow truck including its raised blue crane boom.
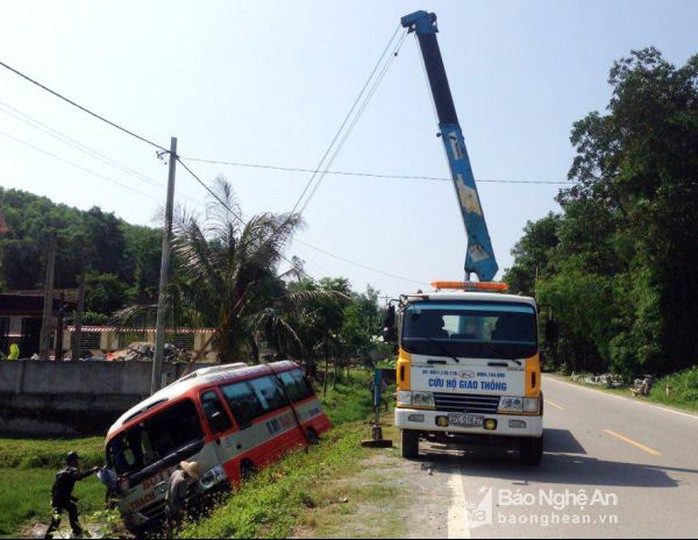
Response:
[387,11,543,465]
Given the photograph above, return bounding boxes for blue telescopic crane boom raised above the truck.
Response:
[400,11,499,281]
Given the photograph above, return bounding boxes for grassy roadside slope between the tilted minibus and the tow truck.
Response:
[181,372,378,538]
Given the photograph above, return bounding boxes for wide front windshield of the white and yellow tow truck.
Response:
[401,301,538,359]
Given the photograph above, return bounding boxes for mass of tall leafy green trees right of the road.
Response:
[510,47,698,376]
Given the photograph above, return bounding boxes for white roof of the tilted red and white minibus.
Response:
[107,360,299,438]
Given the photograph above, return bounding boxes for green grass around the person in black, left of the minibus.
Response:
[0,437,104,537]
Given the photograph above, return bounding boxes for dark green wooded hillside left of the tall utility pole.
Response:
[0,188,162,315]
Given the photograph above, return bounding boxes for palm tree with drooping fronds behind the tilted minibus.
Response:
[170,177,302,363]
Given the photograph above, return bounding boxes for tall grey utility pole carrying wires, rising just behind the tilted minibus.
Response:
[150,137,177,394]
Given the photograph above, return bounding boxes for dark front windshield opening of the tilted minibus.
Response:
[107,399,204,475]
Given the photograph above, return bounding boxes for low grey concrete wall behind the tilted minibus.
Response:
[0,360,210,437]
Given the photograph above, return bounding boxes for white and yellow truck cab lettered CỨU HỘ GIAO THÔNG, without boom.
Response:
[395,282,543,465]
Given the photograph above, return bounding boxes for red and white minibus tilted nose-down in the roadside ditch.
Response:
[100,360,331,531]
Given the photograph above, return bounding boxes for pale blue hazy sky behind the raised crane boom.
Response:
[0,0,698,297]
